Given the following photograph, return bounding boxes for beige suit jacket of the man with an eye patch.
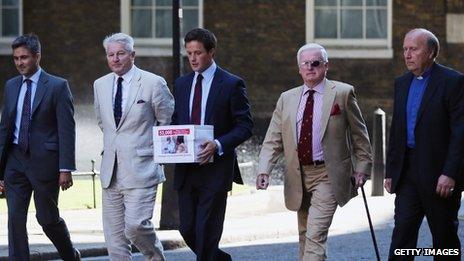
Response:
[258,80,372,211]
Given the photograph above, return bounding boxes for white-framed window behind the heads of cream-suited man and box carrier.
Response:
[121,0,203,56]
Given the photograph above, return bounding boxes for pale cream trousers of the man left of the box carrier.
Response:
[102,164,165,261]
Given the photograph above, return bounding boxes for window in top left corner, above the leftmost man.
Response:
[0,0,22,54]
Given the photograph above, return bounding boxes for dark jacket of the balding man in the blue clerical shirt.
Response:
[386,64,464,193]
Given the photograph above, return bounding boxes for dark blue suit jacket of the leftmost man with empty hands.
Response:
[0,70,75,181]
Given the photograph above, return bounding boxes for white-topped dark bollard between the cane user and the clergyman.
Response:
[371,108,386,196]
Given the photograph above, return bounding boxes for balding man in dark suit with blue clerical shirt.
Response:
[385,29,464,260]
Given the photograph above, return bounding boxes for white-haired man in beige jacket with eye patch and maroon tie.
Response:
[256,44,372,260]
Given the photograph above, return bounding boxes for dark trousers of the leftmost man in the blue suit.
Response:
[5,146,75,261]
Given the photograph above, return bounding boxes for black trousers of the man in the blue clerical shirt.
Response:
[389,150,461,260]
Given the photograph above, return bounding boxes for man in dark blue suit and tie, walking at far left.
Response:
[0,34,80,260]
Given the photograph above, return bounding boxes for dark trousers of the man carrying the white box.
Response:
[178,169,232,261]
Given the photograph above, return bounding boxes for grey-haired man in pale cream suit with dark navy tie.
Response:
[94,33,174,261]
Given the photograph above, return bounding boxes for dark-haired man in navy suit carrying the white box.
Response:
[172,28,253,260]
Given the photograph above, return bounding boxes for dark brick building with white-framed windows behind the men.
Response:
[0,0,464,136]
